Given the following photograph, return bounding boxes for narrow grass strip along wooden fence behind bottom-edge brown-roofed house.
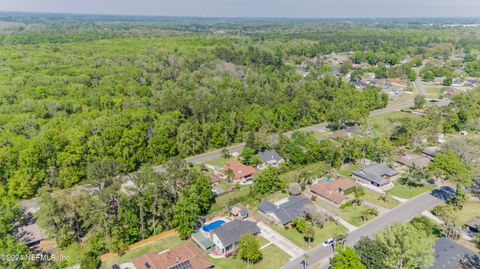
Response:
[100,235,185,269]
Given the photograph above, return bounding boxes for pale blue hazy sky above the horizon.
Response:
[0,0,480,18]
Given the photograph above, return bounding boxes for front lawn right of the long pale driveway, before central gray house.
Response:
[271,221,347,249]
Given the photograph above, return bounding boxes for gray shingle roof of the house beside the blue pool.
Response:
[212,220,260,246]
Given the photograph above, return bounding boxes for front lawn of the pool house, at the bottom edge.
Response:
[209,244,290,269]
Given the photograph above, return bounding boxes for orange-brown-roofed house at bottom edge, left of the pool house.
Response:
[132,241,214,269]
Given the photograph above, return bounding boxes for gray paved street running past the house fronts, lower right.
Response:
[282,193,443,269]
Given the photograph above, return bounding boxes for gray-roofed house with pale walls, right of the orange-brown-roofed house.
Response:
[352,163,398,189]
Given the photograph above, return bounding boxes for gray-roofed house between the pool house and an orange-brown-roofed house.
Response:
[258,196,311,225]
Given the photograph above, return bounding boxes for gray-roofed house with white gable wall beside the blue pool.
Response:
[210,220,260,257]
